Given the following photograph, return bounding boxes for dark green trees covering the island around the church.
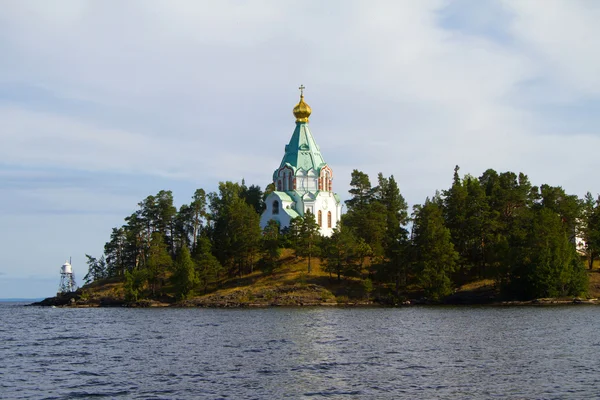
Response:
[94,166,600,301]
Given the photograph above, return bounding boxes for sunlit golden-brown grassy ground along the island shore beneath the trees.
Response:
[82,253,600,307]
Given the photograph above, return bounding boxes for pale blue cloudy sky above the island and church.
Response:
[0,0,600,298]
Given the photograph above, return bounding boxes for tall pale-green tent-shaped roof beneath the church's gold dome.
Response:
[279,122,325,171]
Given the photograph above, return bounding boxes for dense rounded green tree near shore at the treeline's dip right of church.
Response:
[413,199,458,300]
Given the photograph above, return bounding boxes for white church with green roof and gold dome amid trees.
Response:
[260,86,342,236]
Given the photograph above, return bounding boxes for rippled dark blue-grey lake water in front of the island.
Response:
[0,303,600,399]
